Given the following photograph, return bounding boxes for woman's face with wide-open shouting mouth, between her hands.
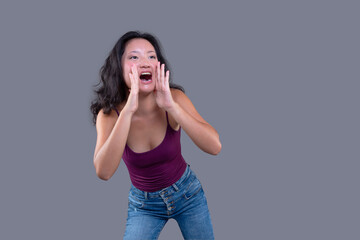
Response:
[121,38,158,92]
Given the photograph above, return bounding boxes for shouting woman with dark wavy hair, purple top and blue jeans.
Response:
[91,32,221,239]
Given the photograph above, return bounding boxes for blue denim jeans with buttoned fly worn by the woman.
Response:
[124,166,214,240]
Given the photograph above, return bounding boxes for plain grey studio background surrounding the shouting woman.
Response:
[0,0,360,240]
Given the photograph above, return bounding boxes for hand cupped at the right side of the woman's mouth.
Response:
[155,62,174,110]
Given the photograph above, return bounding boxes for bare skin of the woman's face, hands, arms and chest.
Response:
[94,38,221,180]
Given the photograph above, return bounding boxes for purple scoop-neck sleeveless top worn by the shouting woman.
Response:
[115,109,187,192]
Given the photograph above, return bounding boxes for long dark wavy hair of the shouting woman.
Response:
[90,31,185,124]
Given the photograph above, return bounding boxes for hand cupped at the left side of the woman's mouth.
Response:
[123,65,140,114]
